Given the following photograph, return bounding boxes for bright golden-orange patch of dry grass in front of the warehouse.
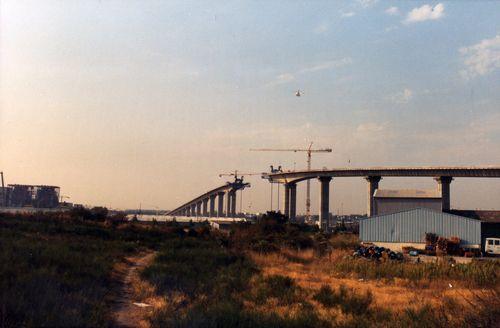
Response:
[250,250,480,315]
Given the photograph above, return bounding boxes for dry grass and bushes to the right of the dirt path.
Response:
[143,215,500,327]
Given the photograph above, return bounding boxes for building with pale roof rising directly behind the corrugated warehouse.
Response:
[374,189,443,215]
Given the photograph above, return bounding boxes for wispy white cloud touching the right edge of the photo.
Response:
[459,35,500,78]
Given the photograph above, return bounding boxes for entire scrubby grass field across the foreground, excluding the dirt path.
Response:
[0,211,500,327]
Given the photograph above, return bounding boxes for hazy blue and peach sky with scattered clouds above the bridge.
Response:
[0,0,500,214]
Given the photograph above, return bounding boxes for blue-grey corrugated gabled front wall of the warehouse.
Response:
[359,208,481,245]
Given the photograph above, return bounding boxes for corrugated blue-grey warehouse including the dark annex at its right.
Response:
[359,208,500,251]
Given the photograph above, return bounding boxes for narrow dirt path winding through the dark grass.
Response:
[112,251,156,327]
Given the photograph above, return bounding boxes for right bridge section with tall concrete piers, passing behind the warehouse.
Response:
[263,166,500,228]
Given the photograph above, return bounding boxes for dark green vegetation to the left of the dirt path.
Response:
[0,214,180,327]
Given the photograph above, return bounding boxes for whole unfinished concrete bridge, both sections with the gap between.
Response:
[169,166,500,228]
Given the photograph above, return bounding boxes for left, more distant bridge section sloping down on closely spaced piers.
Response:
[167,178,250,218]
